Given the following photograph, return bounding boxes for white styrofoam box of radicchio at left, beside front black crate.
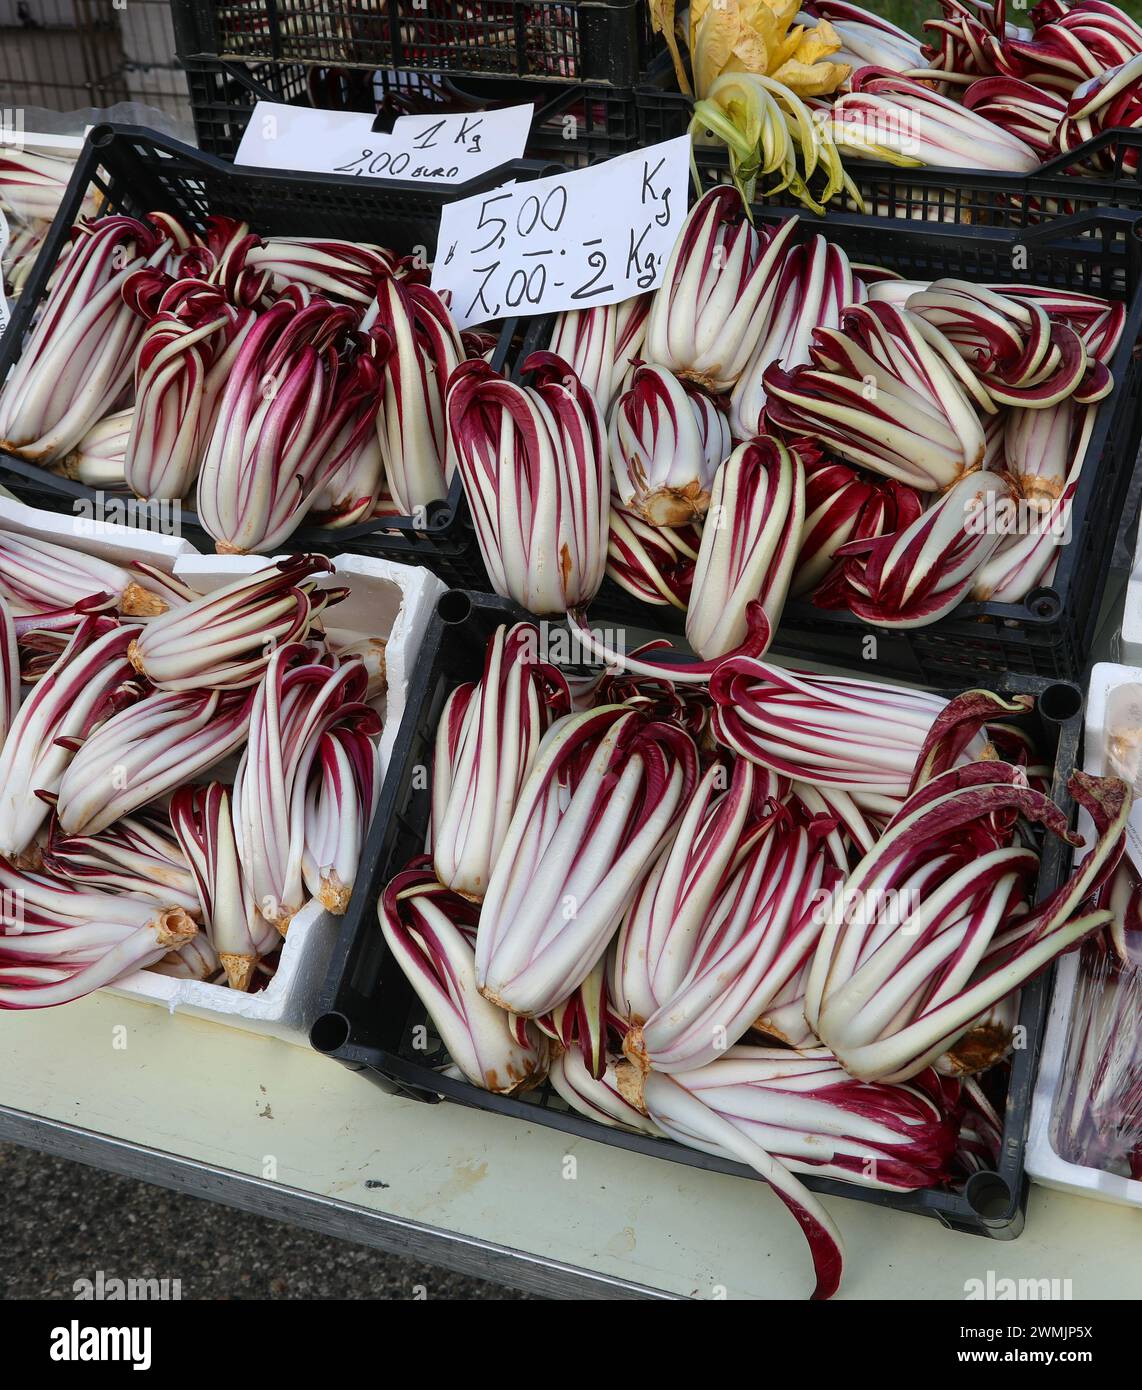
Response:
[106,552,446,1045]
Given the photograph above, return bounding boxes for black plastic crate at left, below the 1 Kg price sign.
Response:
[0,125,549,587]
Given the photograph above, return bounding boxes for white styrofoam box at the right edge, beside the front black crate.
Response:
[1027,662,1142,1207]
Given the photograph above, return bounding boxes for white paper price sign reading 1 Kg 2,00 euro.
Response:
[235,101,535,183]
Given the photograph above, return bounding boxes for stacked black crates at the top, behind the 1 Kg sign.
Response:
[172,0,660,165]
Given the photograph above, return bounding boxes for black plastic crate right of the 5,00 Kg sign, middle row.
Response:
[590,206,1142,685]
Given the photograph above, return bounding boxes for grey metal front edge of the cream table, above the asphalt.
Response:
[0,1105,681,1300]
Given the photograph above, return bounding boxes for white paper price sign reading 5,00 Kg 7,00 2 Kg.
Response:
[432,135,690,328]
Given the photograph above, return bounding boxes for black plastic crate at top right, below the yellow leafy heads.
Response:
[635,79,1142,227]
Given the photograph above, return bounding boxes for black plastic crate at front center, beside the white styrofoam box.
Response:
[310,592,1082,1238]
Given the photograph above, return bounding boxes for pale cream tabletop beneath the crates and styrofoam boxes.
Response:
[0,995,1142,1300]
